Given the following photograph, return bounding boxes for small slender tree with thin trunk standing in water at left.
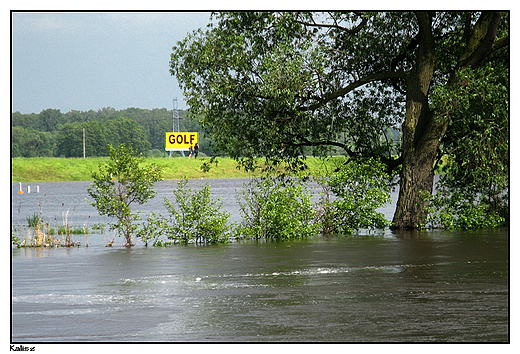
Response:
[88,144,161,247]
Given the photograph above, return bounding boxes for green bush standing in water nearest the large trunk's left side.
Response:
[317,159,390,234]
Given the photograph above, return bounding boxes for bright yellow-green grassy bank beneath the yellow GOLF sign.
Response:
[11,157,346,182]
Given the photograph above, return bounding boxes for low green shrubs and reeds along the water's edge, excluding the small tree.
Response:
[12,155,506,247]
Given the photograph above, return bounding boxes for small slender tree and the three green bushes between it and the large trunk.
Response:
[81,144,398,247]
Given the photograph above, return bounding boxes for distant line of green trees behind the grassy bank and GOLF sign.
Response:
[11,107,211,157]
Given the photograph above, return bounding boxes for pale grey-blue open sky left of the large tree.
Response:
[12,12,210,113]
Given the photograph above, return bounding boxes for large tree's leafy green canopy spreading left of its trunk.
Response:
[170,12,415,168]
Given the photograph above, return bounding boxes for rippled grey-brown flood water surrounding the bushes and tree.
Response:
[11,180,509,343]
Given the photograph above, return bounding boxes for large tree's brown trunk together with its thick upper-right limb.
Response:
[392,12,508,229]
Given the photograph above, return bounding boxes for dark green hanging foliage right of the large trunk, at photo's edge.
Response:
[434,66,509,188]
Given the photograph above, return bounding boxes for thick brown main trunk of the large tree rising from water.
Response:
[392,13,447,229]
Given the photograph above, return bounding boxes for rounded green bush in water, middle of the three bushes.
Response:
[237,178,319,240]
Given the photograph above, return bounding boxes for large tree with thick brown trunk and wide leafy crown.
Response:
[170,12,509,228]
